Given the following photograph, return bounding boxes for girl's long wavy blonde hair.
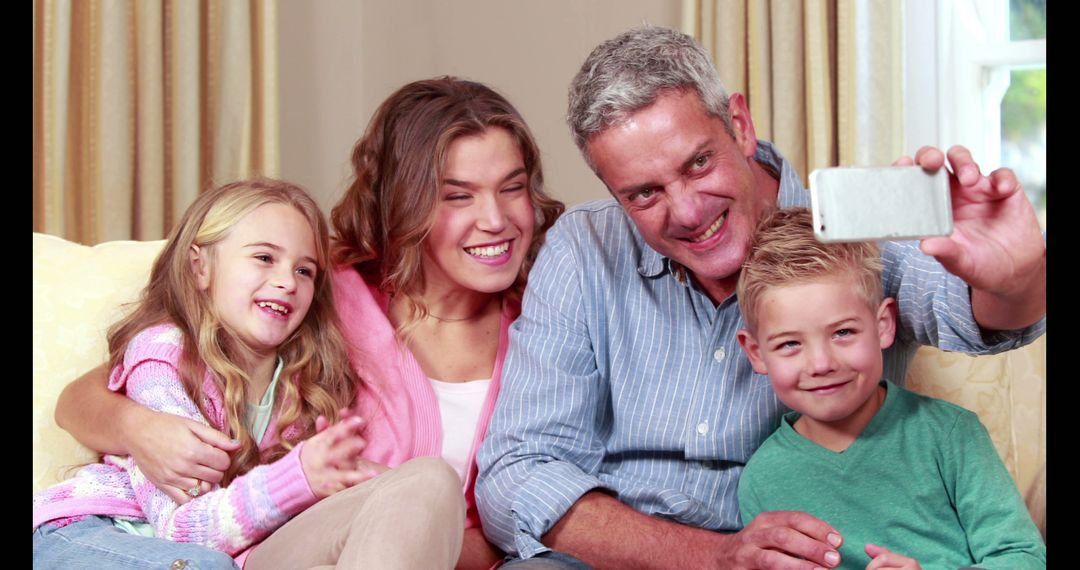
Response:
[108,178,357,485]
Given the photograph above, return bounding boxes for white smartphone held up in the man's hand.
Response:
[810,166,953,242]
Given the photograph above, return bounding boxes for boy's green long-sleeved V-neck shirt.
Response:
[739,381,1047,570]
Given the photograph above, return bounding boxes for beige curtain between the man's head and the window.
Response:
[684,0,904,181]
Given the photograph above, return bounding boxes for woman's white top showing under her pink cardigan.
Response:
[428,378,491,481]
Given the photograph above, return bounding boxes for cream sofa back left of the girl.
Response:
[33,233,165,492]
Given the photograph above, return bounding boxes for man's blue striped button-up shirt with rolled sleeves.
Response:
[476,143,1043,558]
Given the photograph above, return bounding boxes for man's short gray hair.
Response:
[566,26,732,169]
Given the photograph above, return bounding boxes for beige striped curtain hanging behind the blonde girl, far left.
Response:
[33,0,279,244]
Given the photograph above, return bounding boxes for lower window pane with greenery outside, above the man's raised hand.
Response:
[1001,67,1047,229]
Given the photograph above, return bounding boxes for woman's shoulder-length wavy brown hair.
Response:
[330,77,565,334]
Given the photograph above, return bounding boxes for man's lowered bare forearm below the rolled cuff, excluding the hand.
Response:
[542,491,730,569]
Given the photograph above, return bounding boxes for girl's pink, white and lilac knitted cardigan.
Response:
[33,325,319,564]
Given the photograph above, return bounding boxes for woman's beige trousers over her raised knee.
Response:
[244,458,465,570]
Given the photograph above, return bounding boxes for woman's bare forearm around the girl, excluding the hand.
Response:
[55,364,149,456]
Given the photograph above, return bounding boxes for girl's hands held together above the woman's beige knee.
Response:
[300,416,386,499]
